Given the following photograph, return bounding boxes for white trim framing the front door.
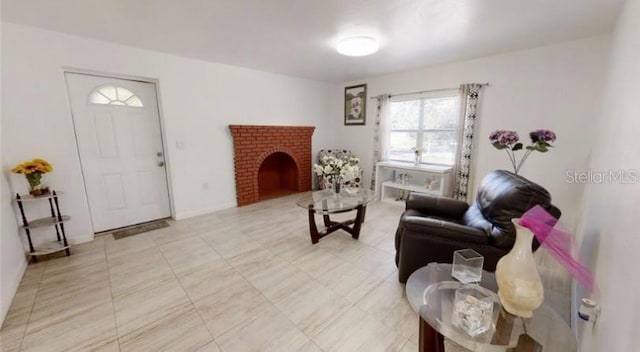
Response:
[61,66,176,236]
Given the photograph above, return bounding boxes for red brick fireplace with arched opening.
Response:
[229,125,315,206]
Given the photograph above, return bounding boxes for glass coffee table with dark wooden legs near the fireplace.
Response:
[296,189,374,244]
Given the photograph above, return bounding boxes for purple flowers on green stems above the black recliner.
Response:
[489,130,556,175]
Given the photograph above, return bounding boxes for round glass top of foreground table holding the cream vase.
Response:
[406,263,577,352]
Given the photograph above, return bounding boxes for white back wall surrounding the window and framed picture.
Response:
[334,36,610,225]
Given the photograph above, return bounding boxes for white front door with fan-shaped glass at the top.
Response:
[65,73,171,232]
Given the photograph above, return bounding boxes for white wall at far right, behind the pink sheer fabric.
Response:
[579,0,640,352]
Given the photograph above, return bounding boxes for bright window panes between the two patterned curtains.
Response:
[388,90,460,165]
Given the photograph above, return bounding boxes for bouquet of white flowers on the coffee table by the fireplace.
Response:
[313,155,362,193]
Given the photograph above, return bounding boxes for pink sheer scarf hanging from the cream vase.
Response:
[520,205,596,292]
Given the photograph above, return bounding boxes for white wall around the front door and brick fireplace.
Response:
[2,23,335,242]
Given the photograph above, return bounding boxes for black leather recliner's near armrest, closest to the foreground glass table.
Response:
[400,215,490,245]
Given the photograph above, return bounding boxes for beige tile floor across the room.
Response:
[0,196,418,352]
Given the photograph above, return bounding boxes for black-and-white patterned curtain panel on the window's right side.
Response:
[453,83,483,201]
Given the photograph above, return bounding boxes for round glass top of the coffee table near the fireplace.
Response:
[296,189,374,214]
